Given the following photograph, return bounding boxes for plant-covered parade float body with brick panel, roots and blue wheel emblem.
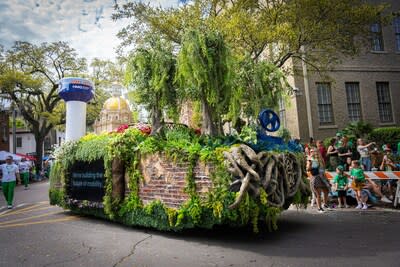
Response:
[49,79,309,232]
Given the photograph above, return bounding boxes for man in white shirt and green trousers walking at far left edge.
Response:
[0,156,21,209]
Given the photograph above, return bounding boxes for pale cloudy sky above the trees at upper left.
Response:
[0,0,178,61]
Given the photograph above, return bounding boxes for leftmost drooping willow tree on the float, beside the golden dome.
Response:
[125,36,177,134]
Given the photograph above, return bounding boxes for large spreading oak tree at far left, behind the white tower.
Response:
[0,42,86,170]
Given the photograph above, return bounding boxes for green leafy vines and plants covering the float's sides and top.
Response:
[49,129,305,232]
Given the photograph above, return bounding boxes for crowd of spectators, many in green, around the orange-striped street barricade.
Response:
[304,134,400,215]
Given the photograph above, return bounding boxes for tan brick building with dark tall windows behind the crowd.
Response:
[280,0,400,141]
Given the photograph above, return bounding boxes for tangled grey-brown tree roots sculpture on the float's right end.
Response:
[224,144,309,209]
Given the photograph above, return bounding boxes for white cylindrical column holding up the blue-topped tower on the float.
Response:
[65,101,86,141]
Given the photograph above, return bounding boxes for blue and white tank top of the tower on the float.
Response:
[58,77,94,102]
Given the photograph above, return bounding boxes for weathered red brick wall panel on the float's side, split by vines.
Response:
[139,155,213,208]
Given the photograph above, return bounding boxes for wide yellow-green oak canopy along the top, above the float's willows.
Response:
[113,0,388,68]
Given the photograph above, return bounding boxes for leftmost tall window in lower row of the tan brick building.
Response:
[317,83,333,125]
